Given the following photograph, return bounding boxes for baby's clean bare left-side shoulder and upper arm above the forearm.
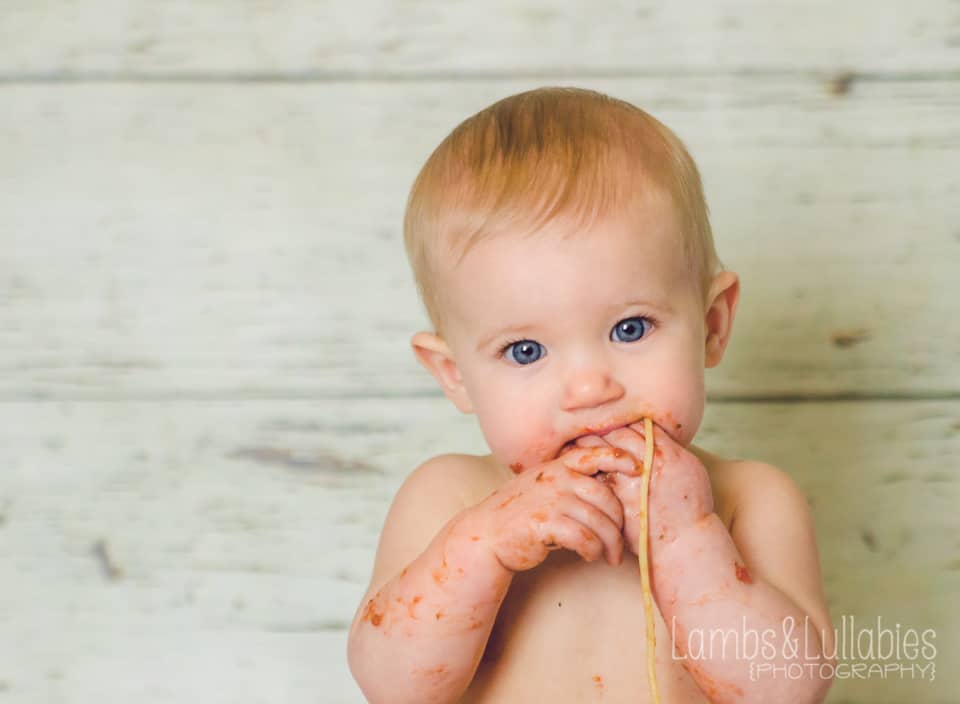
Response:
[365,454,496,598]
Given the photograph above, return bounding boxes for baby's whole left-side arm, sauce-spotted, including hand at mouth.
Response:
[348,447,635,704]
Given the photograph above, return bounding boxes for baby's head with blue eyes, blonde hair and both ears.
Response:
[404,88,739,470]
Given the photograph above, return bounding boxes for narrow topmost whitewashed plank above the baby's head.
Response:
[0,0,960,80]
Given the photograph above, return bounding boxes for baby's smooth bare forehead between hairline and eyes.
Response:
[449,195,690,331]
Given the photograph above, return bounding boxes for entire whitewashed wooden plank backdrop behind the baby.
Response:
[0,0,960,704]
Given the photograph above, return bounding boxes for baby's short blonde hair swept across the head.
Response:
[403,87,722,335]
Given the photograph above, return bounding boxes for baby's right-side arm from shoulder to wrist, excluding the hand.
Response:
[650,464,833,704]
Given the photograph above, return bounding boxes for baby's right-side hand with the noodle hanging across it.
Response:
[576,422,713,555]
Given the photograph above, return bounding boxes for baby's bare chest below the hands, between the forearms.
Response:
[462,551,706,704]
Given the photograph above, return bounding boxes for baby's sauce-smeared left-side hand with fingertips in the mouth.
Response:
[469,446,634,572]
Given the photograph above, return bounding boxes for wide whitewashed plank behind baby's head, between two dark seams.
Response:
[0,77,960,399]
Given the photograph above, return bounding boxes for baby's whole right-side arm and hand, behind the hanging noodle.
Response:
[577,424,833,704]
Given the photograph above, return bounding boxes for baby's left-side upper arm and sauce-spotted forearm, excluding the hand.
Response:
[348,455,513,704]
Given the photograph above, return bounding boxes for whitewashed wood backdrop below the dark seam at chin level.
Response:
[0,399,960,704]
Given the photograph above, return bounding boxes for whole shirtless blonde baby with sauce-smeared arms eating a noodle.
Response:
[348,88,834,704]
